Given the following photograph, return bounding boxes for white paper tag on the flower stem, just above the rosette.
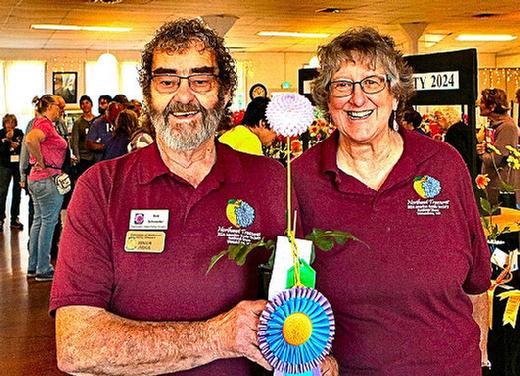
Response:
[269,236,313,299]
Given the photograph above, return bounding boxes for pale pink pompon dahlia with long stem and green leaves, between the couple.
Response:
[206,93,358,274]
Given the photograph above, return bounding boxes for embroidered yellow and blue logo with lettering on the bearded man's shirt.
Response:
[217,198,262,244]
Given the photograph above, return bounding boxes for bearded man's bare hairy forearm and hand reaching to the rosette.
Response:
[56,301,270,375]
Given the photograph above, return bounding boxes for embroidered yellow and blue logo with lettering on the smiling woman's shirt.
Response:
[406,175,450,215]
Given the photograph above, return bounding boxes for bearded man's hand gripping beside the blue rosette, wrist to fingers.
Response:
[210,300,272,370]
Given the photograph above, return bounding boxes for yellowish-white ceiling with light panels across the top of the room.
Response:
[0,0,520,55]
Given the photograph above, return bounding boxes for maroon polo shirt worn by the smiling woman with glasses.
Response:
[293,130,491,376]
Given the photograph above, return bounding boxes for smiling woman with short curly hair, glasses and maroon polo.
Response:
[294,28,490,376]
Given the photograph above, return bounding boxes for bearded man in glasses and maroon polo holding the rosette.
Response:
[50,20,286,376]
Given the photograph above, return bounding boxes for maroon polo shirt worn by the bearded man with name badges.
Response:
[50,143,286,376]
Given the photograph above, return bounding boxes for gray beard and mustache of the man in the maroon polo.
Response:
[150,98,224,151]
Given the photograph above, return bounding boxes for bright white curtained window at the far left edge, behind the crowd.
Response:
[0,61,47,131]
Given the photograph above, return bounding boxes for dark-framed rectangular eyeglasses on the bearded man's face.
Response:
[152,73,217,94]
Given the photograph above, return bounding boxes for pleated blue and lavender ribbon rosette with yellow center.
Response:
[258,286,335,376]
